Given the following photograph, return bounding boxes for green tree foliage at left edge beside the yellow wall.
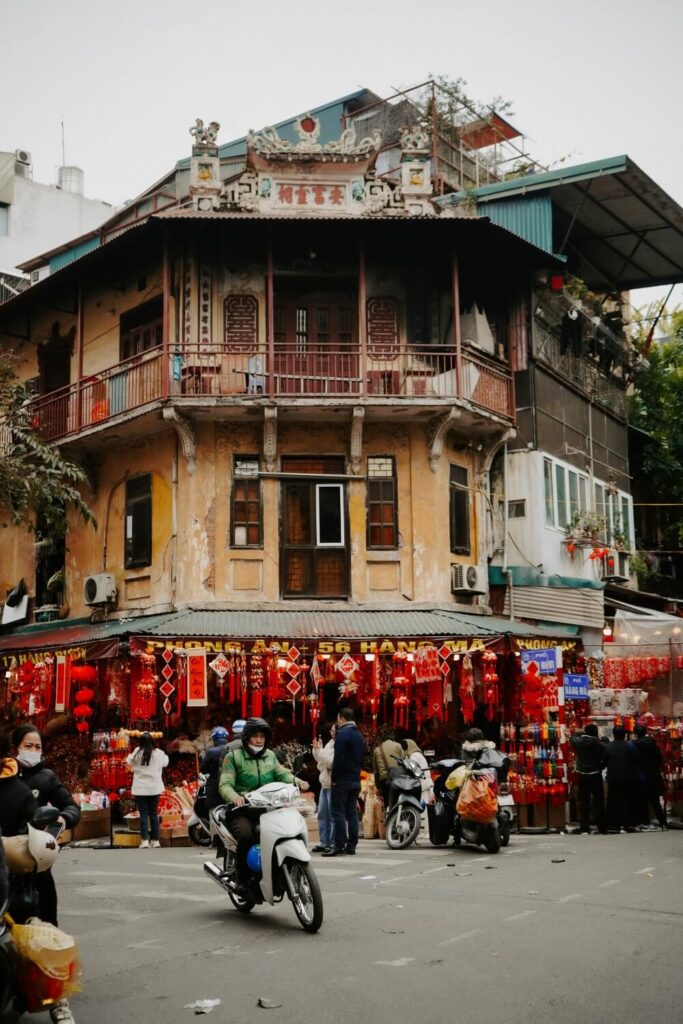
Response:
[0,350,95,545]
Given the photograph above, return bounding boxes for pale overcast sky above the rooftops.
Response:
[0,0,683,311]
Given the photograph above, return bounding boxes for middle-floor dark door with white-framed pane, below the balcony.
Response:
[281,458,348,598]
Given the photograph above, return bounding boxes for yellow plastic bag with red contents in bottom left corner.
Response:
[6,914,81,1013]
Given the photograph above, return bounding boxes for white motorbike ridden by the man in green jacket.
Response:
[204,782,323,932]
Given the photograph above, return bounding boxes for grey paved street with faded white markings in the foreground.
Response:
[35,831,683,1024]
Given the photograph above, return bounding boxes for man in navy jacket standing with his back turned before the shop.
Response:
[322,708,366,857]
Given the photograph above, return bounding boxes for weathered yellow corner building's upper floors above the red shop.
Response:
[0,90,680,745]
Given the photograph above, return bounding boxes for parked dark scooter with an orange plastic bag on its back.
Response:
[427,748,517,853]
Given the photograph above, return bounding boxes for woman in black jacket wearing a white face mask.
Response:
[12,725,81,1024]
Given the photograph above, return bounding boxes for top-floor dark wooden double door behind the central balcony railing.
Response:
[274,290,359,395]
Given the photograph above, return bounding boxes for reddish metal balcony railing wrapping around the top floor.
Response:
[32,343,514,440]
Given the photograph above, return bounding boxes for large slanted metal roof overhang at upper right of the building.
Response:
[436,155,683,291]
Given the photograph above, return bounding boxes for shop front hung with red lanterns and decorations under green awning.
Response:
[2,609,581,839]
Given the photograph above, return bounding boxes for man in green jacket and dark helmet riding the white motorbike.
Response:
[218,718,308,896]
